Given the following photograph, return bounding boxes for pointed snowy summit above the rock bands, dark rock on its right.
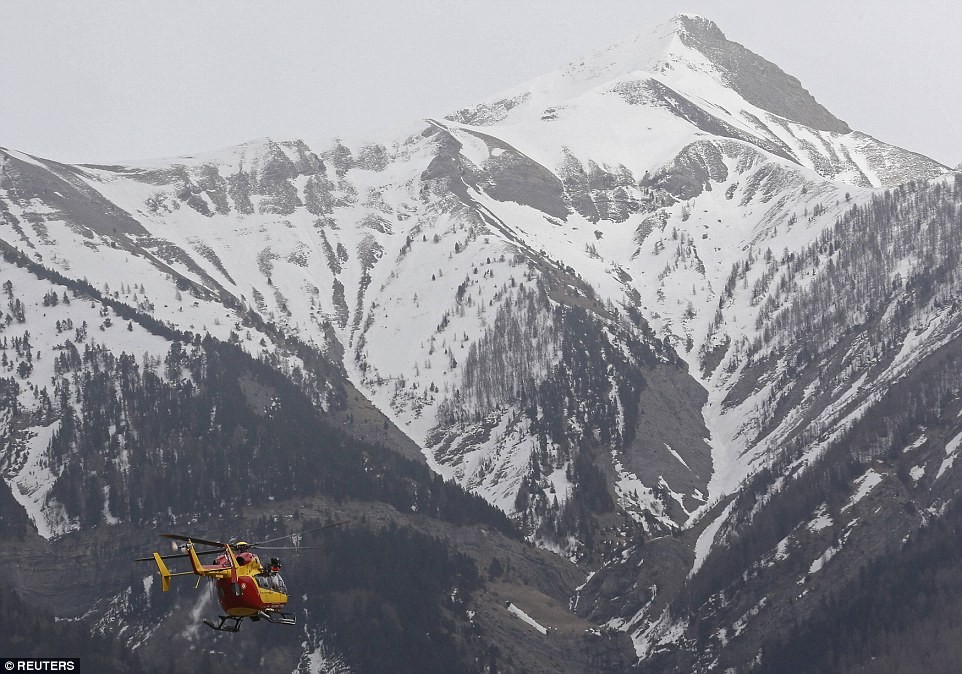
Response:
[450,15,947,186]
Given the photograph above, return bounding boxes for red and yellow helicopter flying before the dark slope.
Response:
[135,520,350,632]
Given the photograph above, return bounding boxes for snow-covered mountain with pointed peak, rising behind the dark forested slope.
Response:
[0,15,962,666]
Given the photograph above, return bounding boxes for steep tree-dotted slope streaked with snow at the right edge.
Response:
[579,176,962,671]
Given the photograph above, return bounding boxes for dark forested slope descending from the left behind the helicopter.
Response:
[0,252,631,672]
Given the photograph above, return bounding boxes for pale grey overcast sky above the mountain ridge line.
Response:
[0,0,962,166]
